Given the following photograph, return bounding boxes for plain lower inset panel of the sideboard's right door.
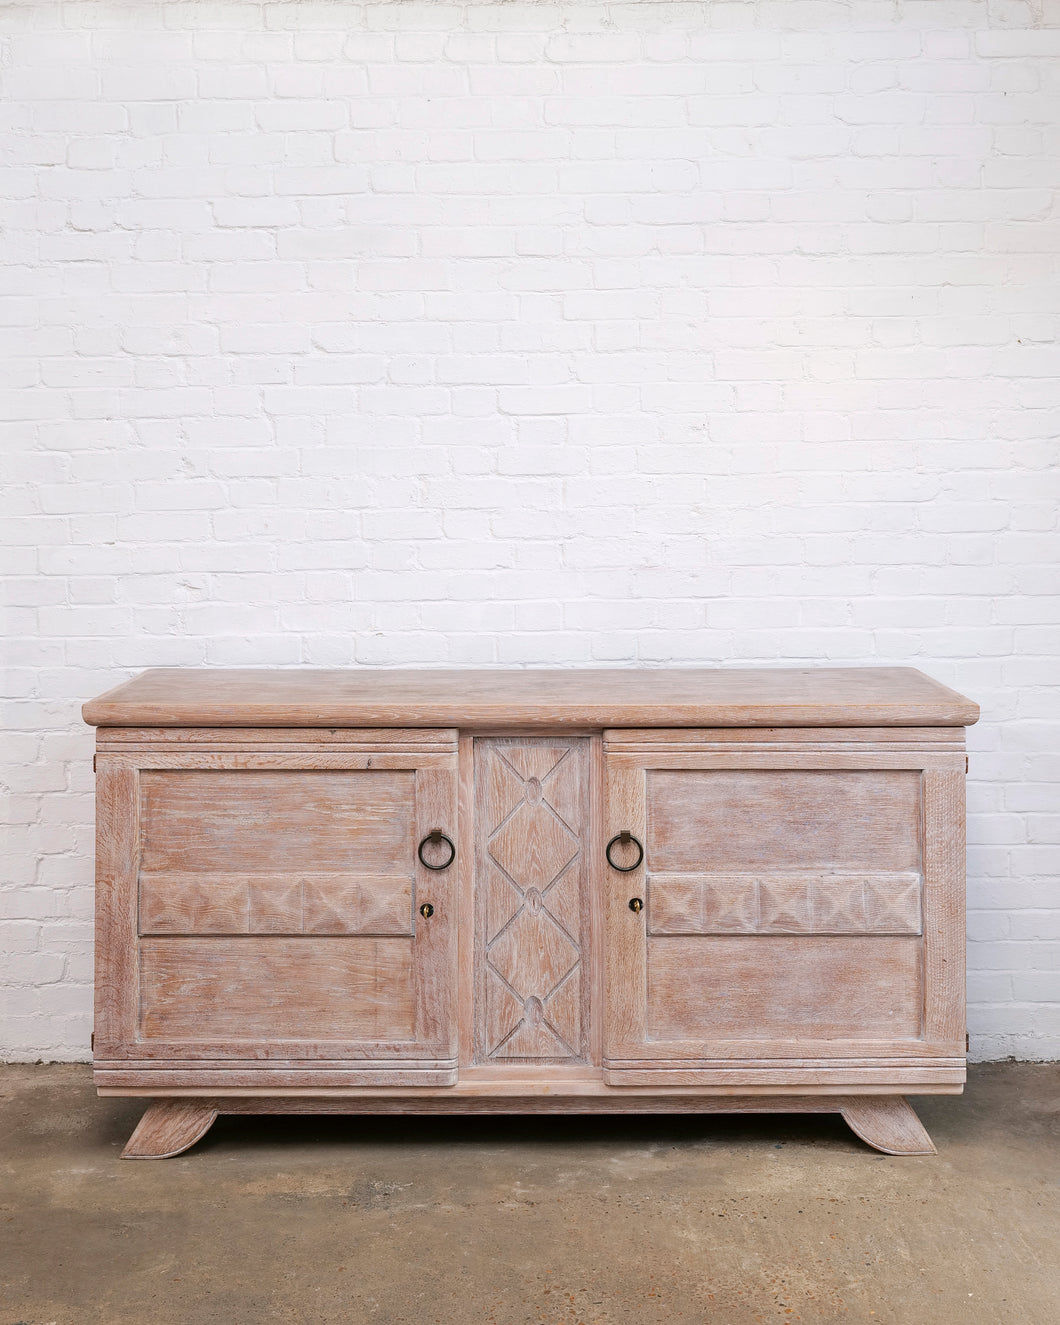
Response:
[647,937,922,1044]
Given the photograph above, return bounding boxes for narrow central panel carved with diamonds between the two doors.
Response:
[474,737,588,1063]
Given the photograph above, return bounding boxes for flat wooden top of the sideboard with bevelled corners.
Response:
[82,668,979,730]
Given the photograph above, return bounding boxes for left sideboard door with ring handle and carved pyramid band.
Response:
[95,733,456,1084]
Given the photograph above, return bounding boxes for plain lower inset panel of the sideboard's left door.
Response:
[140,938,413,1051]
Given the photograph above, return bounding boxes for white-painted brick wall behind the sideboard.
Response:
[0,0,1060,1059]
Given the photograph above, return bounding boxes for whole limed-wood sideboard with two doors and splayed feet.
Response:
[83,668,978,1158]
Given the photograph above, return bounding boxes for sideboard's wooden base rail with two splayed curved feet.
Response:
[122,1092,935,1159]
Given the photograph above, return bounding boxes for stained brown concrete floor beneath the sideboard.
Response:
[0,1064,1060,1325]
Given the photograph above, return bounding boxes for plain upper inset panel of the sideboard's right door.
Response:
[645,769,921,873]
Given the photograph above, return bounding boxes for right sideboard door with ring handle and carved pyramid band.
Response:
[604,733,963,1085]
